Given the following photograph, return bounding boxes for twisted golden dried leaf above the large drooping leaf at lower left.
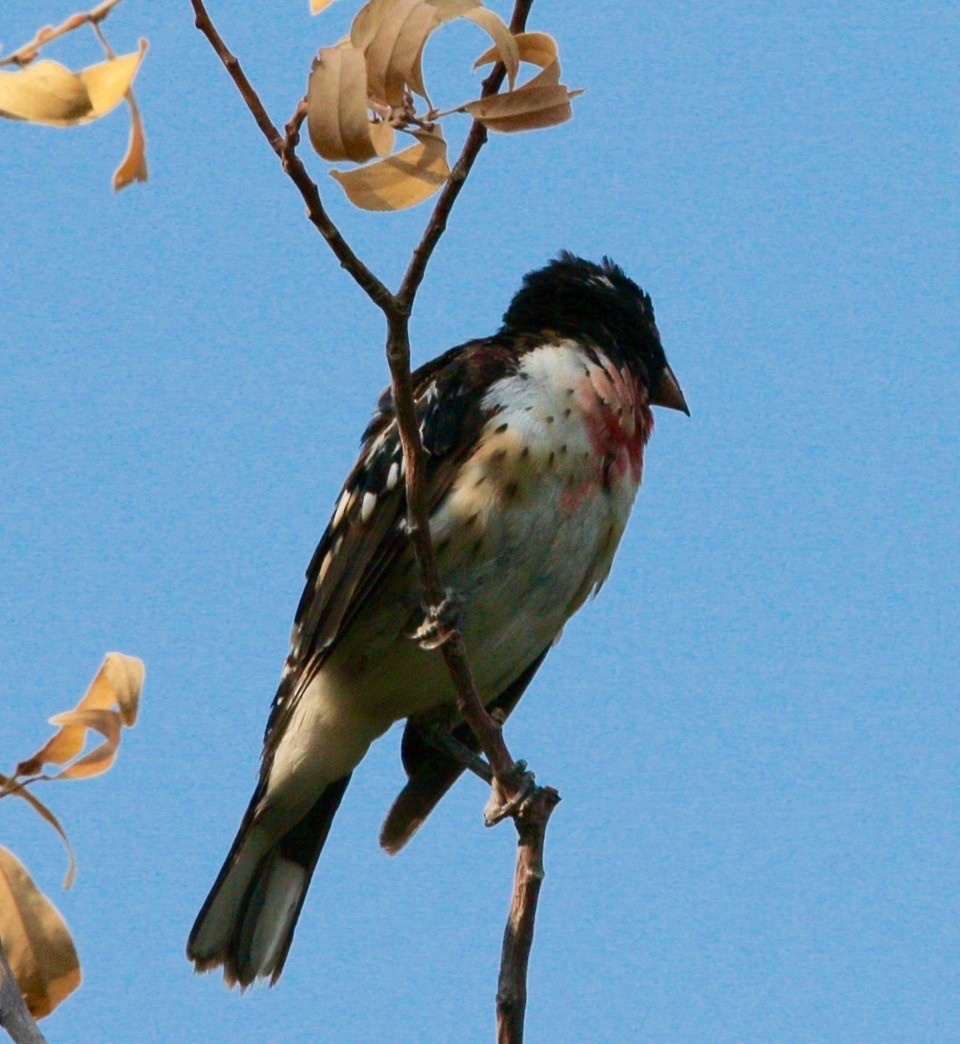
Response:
[16,653,144,779]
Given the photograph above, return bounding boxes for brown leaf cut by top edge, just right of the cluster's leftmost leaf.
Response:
[361,0,441,105]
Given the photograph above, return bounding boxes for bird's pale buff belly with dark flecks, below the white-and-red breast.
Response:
[325,423,637,731]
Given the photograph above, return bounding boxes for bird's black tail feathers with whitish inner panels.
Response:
[187,776,350,989]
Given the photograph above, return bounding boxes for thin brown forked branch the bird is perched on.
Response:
[191,0,559,1044]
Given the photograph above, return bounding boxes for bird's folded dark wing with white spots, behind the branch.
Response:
[262,339,517,774]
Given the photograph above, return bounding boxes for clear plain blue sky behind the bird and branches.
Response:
[0,0,960,1042]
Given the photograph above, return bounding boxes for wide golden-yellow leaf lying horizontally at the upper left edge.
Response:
[0,41,146,127]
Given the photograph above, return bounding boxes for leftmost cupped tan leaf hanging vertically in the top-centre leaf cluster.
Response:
[307,43,393,163]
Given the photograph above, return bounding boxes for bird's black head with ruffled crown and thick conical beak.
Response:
[503,251,690,416]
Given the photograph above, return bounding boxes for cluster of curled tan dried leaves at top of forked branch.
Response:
[307,0,580,211]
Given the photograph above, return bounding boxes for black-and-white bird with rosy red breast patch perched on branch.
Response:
[187,251,690,990]
